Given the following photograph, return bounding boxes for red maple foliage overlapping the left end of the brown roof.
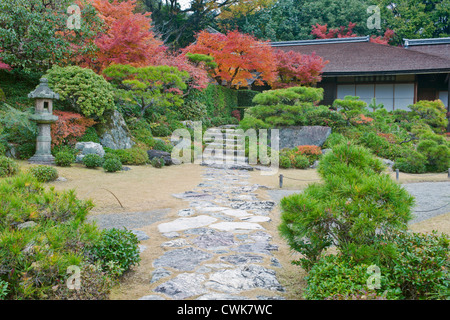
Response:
[274,49,328,88]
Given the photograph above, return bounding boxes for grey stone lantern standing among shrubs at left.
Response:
[28,78,59,165]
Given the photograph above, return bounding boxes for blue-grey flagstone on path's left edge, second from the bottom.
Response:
[153,247,213,271]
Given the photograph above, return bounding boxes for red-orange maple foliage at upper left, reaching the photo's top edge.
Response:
[81,0,165,73]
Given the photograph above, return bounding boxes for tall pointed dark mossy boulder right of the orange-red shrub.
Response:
[97,110,134,150]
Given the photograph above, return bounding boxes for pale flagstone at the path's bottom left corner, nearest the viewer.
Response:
[154,273,208,300]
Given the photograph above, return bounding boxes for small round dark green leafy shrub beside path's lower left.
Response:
[91,228,140,276]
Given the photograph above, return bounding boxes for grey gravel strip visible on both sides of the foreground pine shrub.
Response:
[267,182,450,224]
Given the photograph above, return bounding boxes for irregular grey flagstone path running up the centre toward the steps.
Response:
[140,167,284,300]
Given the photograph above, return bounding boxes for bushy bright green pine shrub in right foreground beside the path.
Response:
[279,144,414,270]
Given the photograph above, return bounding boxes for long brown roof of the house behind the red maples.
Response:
[271,37,450,76]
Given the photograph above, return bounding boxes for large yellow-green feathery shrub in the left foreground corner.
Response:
[0,174,99,300]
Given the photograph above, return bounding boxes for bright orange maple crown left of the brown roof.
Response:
[184,31,277,88]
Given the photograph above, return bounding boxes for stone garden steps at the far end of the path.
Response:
[202,125,253,170]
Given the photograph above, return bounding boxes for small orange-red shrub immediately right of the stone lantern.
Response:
[51,110,96,146]
